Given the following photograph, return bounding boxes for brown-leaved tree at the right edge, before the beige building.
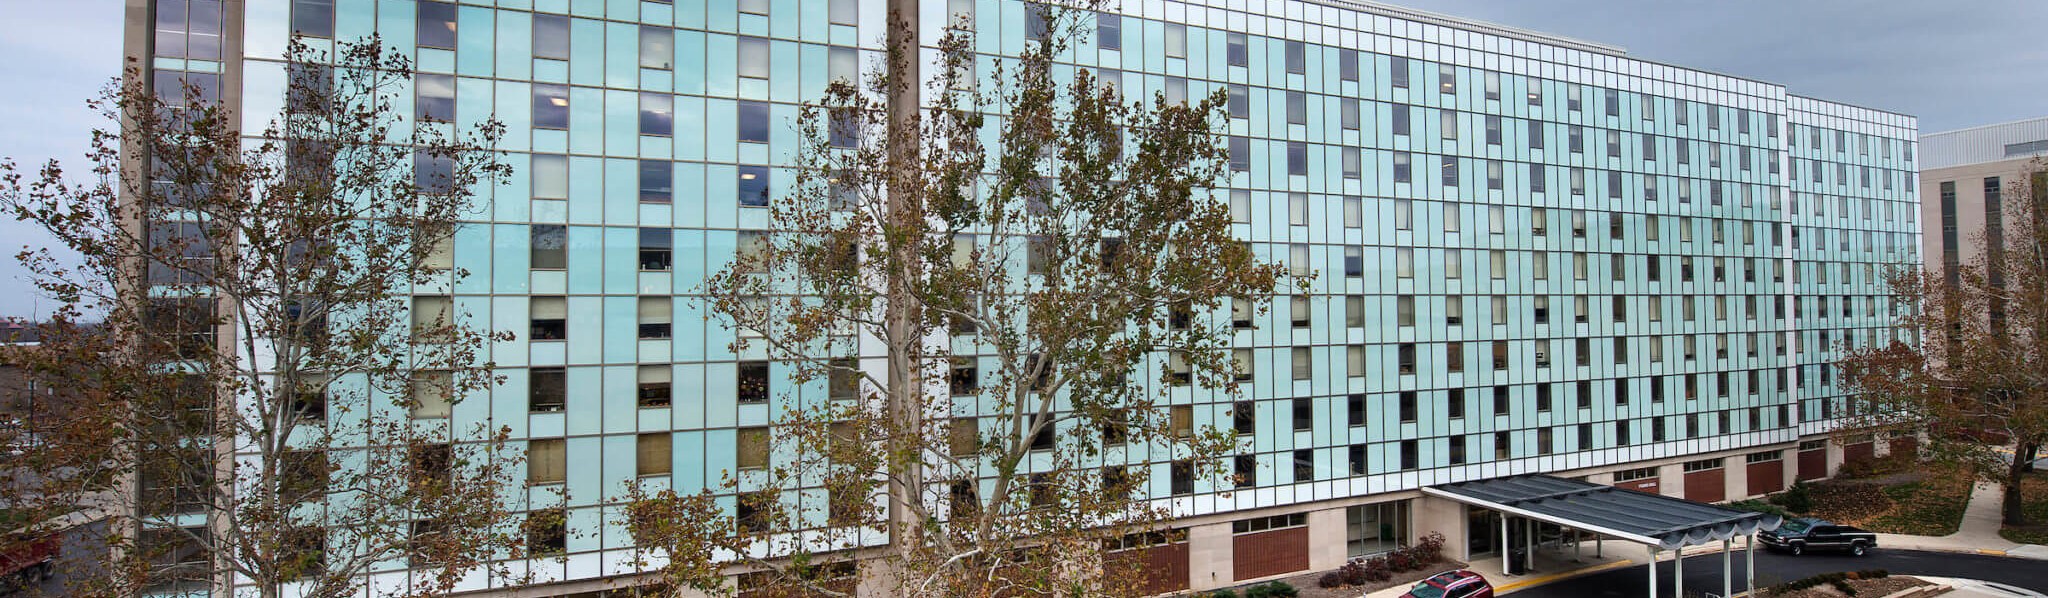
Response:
[1841,160,2048,526]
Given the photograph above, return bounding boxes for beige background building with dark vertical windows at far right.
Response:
[1921,119,2048,284]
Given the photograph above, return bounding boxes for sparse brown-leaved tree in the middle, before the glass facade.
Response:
[629,2,1288,596]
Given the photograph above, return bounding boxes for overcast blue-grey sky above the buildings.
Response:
[0,0,2048,315]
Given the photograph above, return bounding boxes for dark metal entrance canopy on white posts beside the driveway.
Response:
[1421,473,1784,598]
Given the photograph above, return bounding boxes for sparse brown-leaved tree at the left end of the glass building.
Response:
[0,37,522,596]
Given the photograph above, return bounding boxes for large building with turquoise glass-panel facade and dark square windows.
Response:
[129,0,1921,592]
